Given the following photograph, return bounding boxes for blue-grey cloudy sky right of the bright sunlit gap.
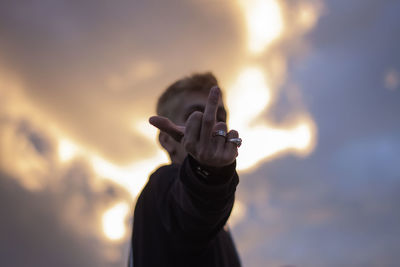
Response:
[234,1,400,267]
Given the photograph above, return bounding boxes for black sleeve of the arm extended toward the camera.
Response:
[156,156,239,248]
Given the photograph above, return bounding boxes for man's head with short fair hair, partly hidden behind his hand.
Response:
[157,72,227,163]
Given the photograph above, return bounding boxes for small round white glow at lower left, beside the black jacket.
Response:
[102,202,129,240]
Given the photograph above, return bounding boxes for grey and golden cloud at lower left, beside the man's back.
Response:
[0,110,131,267]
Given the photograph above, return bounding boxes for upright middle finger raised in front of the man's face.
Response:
[200,86,221,142]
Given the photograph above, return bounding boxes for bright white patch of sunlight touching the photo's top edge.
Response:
[239,0,283,54]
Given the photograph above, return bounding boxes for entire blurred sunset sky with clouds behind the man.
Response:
[0,0,400,267]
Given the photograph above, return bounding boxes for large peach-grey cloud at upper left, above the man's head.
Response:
[0,1,244,164]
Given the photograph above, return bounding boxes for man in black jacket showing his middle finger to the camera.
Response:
[128,73,241,267]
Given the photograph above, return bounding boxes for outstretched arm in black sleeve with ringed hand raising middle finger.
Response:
[150,87,238,249]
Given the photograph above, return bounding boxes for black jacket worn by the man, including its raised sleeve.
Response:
[131,156,240,267]
